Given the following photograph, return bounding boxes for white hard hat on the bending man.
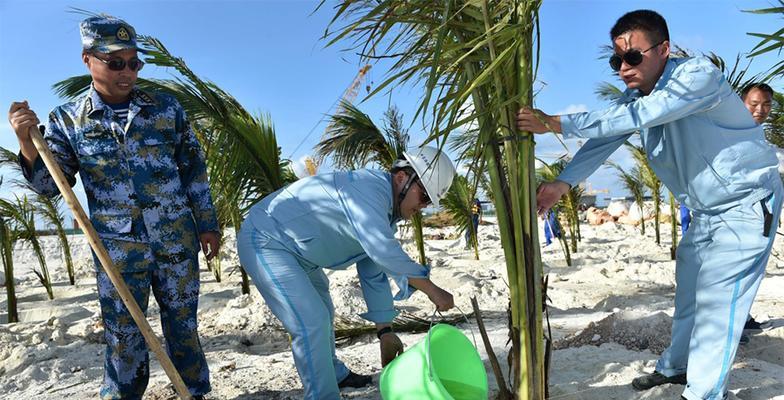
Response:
[403,146,455,207]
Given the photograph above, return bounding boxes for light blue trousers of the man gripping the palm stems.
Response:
[656,184,782,400]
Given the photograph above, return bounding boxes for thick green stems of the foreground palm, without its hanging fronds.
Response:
[482,0,546,400]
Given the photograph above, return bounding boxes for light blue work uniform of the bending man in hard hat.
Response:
[237,170,429,399]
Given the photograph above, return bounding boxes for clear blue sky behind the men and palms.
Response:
[0,0,781,216]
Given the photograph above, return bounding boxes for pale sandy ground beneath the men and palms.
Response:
[0,217,784,400]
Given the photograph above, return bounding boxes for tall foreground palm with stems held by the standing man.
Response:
[321,0,547,399]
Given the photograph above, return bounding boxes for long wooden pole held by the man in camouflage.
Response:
[30,126,192,400]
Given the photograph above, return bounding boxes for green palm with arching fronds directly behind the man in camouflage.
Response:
[54,36,296,293]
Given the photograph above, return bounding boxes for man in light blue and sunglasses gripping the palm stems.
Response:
[517,10,782,400]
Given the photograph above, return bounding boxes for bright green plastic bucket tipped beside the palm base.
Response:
[379,324,487,400]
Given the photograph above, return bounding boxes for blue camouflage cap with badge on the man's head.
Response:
[79,14,144,53]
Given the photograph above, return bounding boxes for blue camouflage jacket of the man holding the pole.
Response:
[23,88,219,270]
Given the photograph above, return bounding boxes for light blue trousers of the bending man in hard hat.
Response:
[237,221,349,400]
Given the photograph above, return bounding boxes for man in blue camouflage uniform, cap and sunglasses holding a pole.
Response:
[9,15,220,399]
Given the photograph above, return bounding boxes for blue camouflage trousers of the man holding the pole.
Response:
[97,257,210,399]
